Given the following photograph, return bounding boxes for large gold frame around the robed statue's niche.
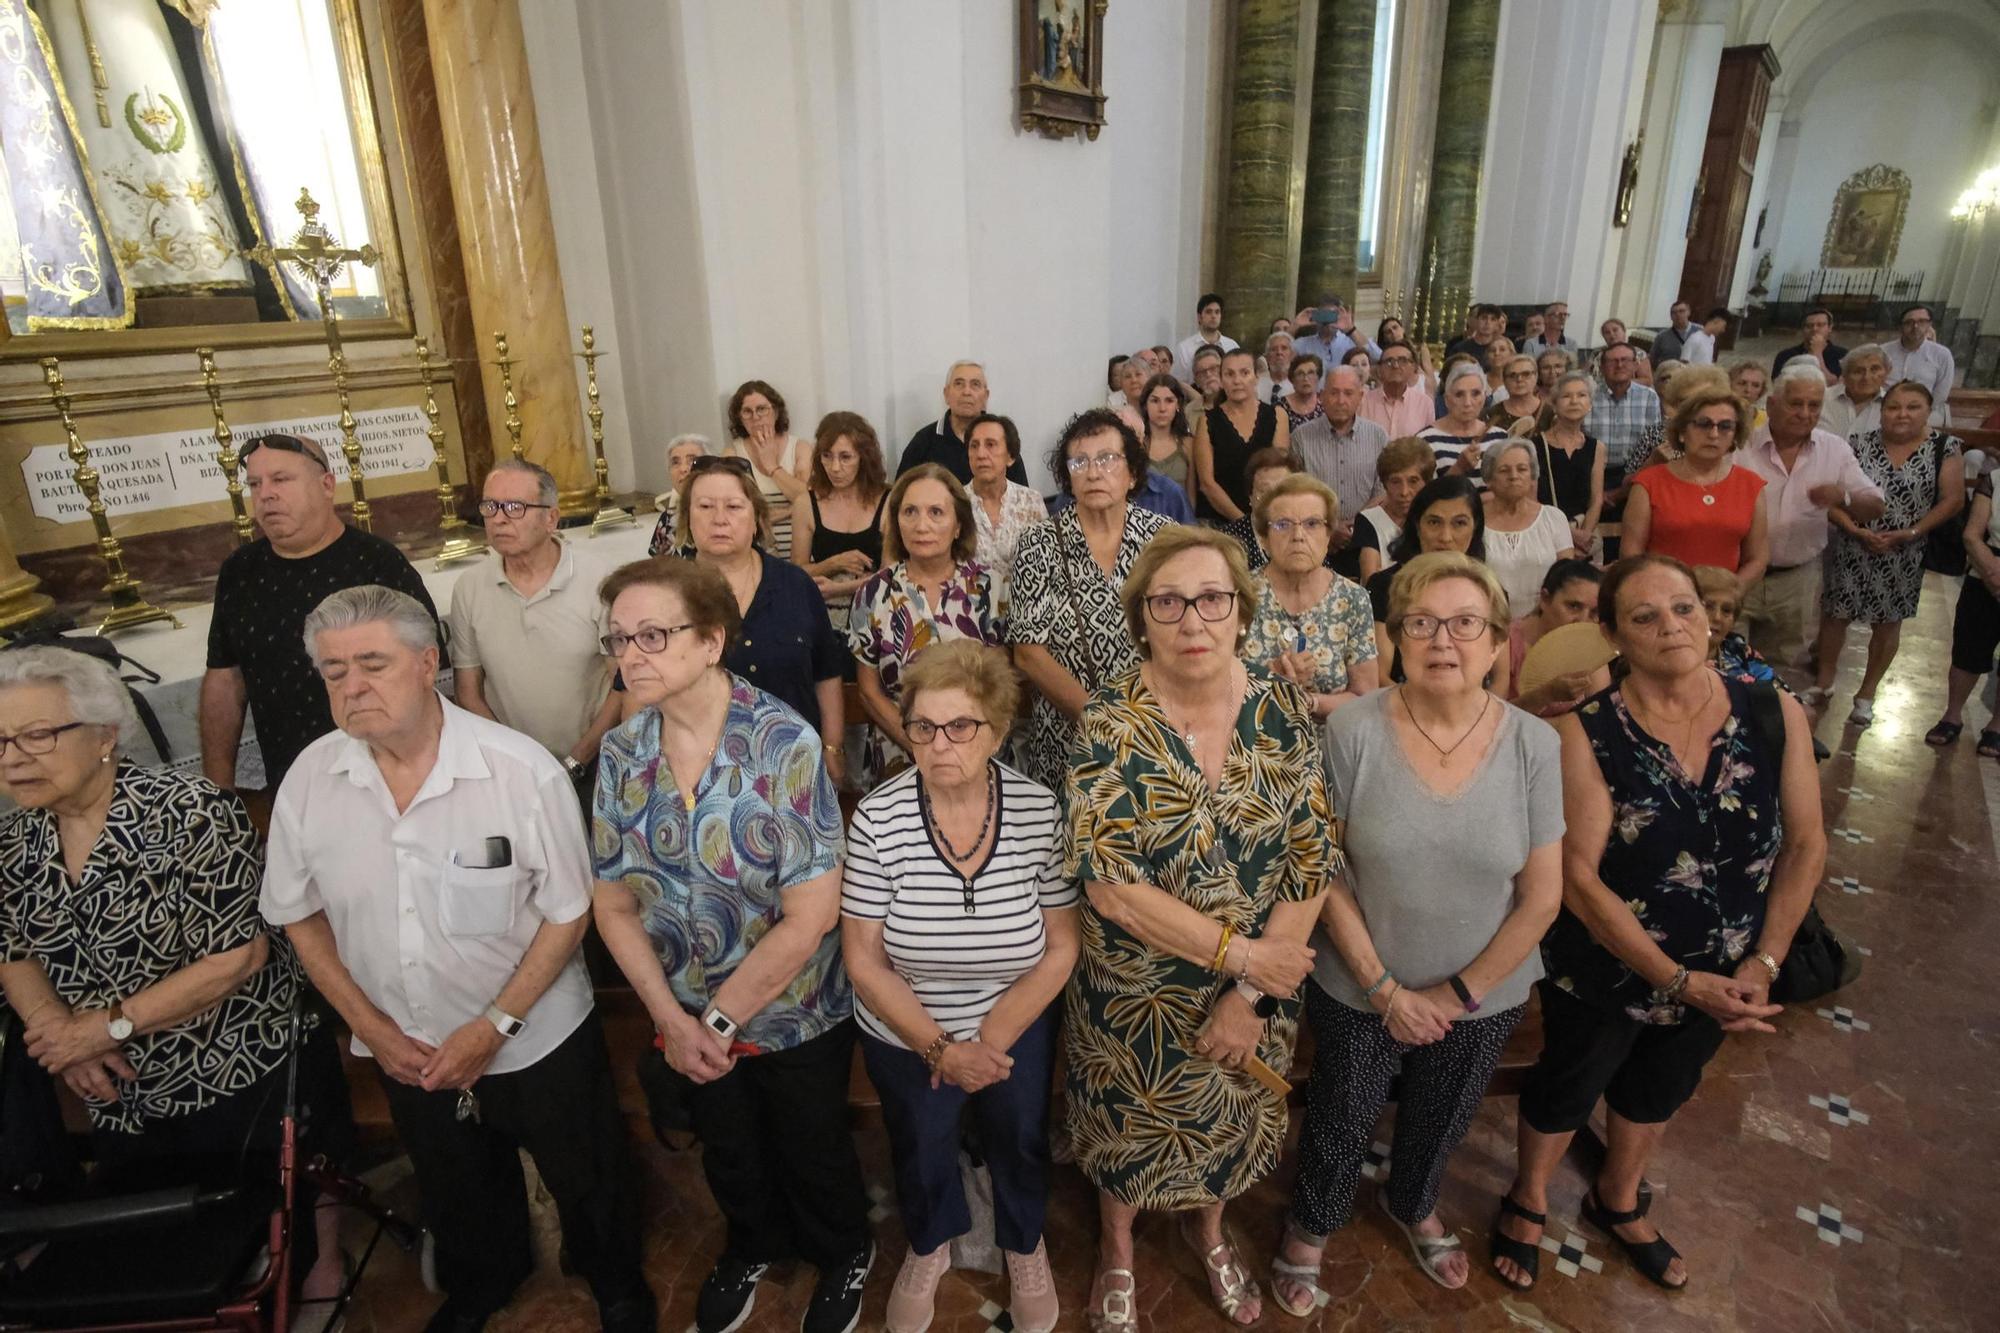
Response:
[0,0,416,362]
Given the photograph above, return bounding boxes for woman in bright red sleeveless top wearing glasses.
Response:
[1620,376,1770,588]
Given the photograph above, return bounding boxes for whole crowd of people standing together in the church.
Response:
[0,282,1968,1333]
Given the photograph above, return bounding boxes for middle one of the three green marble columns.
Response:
[1298,0,1376,306]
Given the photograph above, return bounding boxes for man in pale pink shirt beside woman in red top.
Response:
[1736,362,1882,668]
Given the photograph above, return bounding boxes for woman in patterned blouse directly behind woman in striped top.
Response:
[848,462,1006,777]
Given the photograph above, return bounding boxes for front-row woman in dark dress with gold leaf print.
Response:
[1064,526,1340,1329]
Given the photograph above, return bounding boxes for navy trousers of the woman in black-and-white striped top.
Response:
[862,1005,1056,1255]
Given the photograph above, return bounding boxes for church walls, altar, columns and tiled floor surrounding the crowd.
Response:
[0,0,2000,1333]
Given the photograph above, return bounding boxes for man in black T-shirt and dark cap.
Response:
[200,434,430,791]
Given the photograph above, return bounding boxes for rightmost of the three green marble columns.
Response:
[1418,0,1500,342]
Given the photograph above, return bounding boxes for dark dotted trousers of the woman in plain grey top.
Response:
[1292,985,1526,1235]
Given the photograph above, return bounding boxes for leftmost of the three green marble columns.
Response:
[1222,0,1298,346]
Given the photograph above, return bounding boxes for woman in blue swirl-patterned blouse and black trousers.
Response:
[592,560,874,1331]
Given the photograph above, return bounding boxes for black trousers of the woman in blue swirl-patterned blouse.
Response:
[688,1019,868,1267]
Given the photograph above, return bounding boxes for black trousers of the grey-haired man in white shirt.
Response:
[382,1013,646,1313]
